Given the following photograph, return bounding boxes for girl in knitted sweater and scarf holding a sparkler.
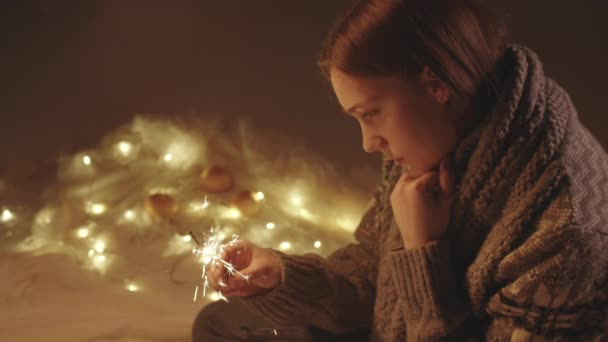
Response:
[193,0,608,341]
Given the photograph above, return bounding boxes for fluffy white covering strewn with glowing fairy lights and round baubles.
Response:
[0,117,367,341]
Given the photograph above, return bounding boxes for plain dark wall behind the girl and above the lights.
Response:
[0,0,608,188]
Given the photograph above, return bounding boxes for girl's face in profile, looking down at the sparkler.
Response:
[330,67,463,177]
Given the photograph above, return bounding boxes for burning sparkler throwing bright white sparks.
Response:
[189,227,249,302]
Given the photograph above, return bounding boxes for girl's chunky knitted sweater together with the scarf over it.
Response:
[244,45,608,341]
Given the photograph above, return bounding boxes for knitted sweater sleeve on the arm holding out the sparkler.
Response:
[241,162,394,334]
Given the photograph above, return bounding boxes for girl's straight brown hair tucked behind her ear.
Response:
[318,0,505,105]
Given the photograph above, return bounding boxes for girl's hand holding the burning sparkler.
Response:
[208,240,283,297]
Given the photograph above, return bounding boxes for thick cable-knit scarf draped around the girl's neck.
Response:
[385,45,576,314]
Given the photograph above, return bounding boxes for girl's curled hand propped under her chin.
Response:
[391,158,454,248]
